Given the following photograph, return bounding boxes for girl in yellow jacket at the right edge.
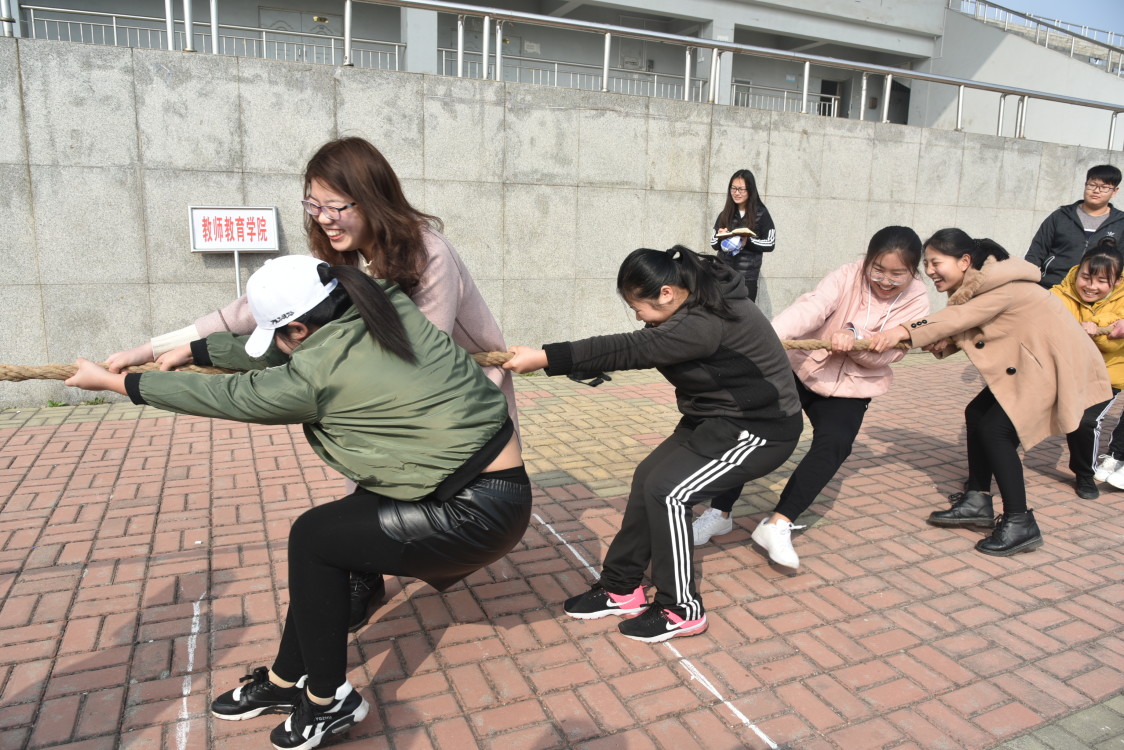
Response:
[1050,237,1124,500]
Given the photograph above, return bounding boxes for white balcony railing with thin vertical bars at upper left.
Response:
[22,6,405,70]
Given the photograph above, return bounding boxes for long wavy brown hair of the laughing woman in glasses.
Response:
[305,137,442,295]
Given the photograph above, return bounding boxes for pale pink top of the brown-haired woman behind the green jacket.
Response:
[161,228,519,426]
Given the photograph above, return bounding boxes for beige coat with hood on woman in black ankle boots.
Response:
[906,257,1113,449]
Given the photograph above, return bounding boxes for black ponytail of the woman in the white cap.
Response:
[277,263,417,364]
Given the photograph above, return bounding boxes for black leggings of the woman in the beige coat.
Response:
[964,388,1026,515]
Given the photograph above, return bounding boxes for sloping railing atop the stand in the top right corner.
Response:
[949,0,1124,76]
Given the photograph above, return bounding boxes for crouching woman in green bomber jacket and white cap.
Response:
[66,255,531,750]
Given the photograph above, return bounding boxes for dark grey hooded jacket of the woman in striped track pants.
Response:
[545,264,800,440]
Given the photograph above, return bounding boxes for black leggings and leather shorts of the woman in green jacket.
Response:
[273,472,531,697]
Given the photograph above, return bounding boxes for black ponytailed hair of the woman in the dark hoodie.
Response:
[617,245,736,320]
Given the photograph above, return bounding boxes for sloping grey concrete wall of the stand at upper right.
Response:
[909,10,1124,149]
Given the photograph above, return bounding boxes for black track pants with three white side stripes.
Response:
[601,418,798,620]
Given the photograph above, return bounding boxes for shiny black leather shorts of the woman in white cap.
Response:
[379,477,531,591]
